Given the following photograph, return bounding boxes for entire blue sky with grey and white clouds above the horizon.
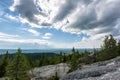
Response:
[0,0,120,49]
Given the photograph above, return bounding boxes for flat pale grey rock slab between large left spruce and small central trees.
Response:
[29,63,69,80]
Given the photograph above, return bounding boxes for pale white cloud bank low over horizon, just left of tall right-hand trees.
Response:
[52,38,102,48]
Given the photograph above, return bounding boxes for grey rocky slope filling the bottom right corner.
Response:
[60,57,120,80]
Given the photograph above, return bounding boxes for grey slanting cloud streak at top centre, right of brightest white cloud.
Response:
[53,0,93,22]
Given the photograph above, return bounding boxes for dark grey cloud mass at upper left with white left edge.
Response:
[10,0,39,24]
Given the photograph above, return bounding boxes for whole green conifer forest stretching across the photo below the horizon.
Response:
[0,35,120,80]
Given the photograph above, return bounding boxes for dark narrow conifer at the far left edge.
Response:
[0,51,9,77]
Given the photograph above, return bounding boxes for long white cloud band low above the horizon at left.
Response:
[0,32,51,46]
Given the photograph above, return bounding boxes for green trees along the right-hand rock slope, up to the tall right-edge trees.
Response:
[69,35,120,72]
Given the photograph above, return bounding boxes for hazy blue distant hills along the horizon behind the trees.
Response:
[0,48,100,54]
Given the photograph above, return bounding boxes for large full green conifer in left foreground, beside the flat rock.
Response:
[6,49,28,80]
